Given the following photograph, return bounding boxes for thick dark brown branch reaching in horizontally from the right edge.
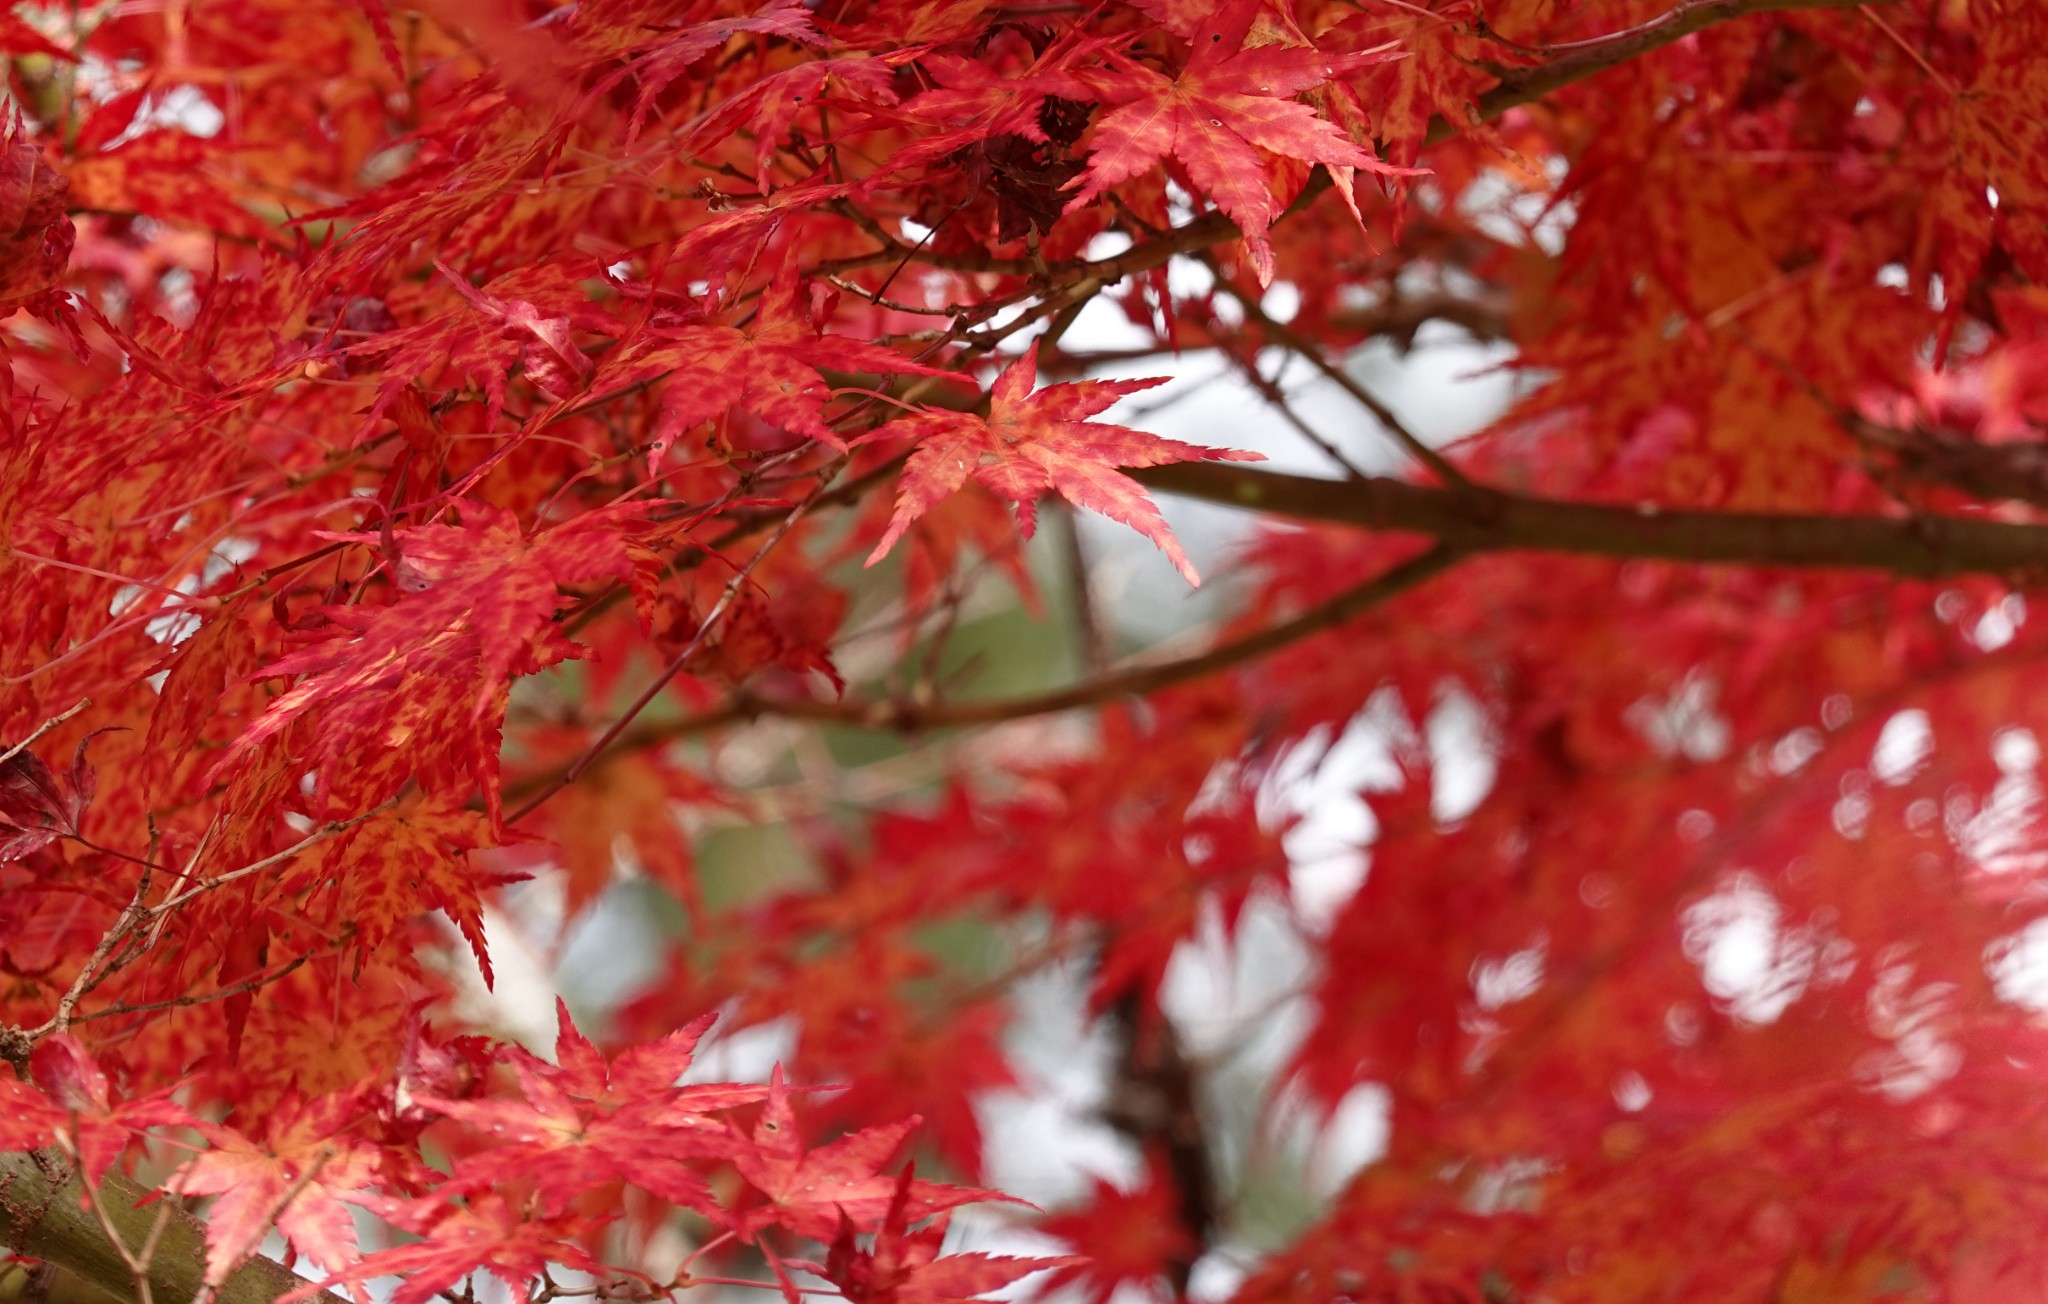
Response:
[1130,463,2048,577]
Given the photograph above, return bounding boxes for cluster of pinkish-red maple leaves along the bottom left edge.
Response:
[0,1009,1067,1304]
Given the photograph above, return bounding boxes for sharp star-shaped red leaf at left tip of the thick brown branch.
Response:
[868,342,1266,585]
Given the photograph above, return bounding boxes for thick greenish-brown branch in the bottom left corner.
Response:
[0,1150,346,1304]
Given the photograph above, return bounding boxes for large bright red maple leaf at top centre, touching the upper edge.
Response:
[1067,0,1397,285]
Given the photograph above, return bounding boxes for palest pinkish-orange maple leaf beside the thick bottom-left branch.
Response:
[170,1091,379,1286]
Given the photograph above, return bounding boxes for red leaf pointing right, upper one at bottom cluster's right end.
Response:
[733,1064,1022,1241]
